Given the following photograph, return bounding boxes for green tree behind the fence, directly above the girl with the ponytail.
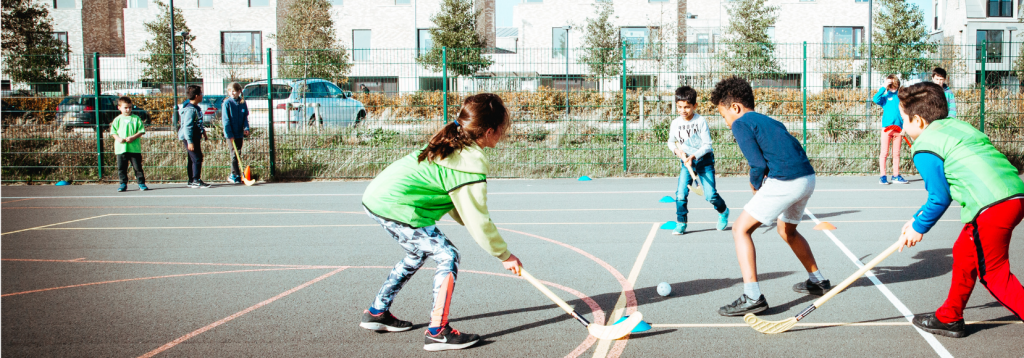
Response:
[416,0,494,77]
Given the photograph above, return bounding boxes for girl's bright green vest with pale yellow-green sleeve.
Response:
[362,144,512,261]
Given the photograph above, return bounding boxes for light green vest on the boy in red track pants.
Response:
[912,118,1024,224]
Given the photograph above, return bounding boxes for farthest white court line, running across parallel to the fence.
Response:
[2,188,927,199]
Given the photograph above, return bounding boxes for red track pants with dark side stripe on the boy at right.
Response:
[935,198,1024,323]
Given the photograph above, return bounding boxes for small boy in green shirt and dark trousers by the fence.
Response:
[111,96,150,192]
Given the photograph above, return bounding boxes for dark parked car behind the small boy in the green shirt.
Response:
[56,95,151,131]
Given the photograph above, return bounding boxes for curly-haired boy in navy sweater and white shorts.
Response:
[711,77,831,316]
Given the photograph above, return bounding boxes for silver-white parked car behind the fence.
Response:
[242,79,367,127]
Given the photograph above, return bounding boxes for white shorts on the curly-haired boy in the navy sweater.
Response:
[743,174,814,225]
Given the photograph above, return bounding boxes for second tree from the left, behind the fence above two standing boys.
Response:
[140,0,202,83]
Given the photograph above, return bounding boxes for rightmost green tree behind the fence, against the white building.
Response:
[872,0,937,78]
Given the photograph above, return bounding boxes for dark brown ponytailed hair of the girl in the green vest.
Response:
[419,93,512,162]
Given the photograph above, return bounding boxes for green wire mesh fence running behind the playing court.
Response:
[2,43,1024,182]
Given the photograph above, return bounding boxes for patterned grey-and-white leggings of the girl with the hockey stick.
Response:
[364,208,459,327]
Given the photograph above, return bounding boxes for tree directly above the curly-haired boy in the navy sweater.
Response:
[720,0,782,79]
